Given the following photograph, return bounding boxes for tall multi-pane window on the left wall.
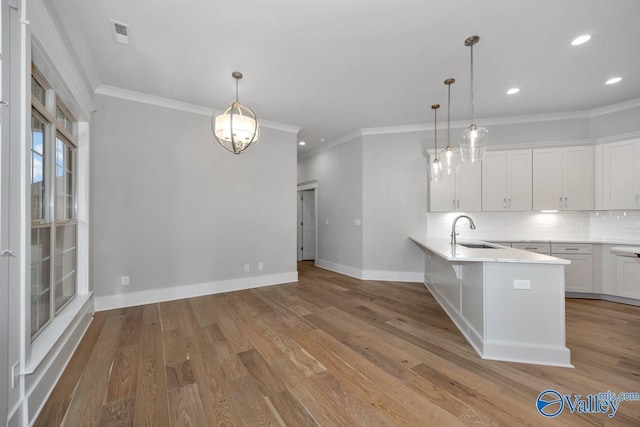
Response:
[29,67,78,339]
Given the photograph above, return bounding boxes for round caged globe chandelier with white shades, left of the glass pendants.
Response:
[211,71,260,154]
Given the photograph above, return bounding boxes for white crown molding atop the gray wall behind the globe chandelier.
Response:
[95,85,300,134]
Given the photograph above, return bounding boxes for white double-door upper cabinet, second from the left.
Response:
[482,150,532,211]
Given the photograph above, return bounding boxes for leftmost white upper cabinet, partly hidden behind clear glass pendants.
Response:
[429,162,482,212]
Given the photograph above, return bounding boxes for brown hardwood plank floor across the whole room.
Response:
[36,262,640,427]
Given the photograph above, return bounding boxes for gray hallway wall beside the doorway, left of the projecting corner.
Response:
[298,137,363,277]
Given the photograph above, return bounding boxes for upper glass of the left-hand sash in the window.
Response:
[31,116,46,219]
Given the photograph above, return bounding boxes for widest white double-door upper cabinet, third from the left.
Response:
[533,146,594,211]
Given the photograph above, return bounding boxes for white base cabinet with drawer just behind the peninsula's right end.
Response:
[551,243,593,293]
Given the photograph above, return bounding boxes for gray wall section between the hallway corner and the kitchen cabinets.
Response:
[362,133,427,281]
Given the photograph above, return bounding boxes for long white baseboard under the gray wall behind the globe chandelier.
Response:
[96,271,298,311]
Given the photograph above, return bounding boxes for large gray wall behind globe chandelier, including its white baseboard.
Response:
[92,95,297,309]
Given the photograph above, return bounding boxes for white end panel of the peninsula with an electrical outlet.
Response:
[483,263,571,366]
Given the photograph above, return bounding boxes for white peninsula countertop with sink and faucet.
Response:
[409,235,571,264]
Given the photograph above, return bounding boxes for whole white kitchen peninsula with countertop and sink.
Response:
[410,235,572,367]
